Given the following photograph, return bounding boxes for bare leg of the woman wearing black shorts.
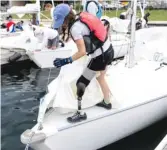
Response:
[97,70,111,104]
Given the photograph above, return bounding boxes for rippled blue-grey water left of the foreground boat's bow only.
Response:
[1,62,59,150]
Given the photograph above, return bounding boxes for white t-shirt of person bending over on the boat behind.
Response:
[34,27,58,49]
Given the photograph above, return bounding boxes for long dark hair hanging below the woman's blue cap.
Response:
[62,11,76,41]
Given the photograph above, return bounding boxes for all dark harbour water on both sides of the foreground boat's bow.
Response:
[1,61,167,150]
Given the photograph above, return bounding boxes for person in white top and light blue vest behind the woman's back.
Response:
[84,0,102,19]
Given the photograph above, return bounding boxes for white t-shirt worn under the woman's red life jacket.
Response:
[70,21,110,58]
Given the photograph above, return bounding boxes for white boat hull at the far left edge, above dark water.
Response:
[0,25,41,65]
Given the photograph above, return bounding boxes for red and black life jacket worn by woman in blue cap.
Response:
[70,12,107,54]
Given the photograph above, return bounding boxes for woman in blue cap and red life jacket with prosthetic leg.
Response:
[53,4,114,122]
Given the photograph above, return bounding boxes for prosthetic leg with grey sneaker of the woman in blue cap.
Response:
[67,82,87,123]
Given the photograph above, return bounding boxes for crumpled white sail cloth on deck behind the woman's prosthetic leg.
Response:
[48,56,103,110]
